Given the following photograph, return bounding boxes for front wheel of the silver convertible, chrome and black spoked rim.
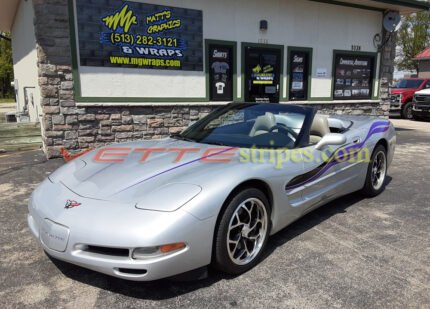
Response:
[213,188,270,275]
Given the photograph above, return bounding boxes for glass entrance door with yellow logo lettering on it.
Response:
[245,47,282,103]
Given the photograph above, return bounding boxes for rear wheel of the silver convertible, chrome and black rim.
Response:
[361,145,388,197]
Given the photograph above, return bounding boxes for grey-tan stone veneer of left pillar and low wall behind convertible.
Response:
[33,0,390,158]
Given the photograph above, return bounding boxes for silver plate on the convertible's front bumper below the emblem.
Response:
[40,219,69,252]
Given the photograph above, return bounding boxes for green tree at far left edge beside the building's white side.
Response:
[0,33,13,98]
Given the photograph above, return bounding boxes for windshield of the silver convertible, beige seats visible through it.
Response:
[172,103,313,149]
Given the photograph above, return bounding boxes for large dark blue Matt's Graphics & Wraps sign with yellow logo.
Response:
[76,0,203,71]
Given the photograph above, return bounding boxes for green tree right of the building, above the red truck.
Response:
[397,12,430,71]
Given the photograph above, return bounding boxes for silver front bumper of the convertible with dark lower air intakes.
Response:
[28,181,216,281]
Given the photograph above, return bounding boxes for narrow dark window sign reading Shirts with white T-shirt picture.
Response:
[207,43,235,101]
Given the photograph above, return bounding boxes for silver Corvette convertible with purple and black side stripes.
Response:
[28,103,396,281]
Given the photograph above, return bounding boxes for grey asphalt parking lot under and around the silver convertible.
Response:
[0,120,430,308]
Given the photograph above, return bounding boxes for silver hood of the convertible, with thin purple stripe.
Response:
[50,139,239,202]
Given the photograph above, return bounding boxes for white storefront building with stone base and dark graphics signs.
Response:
[0,0,429,157]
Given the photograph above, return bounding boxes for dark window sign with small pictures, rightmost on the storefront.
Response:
[333,54,375,100]
